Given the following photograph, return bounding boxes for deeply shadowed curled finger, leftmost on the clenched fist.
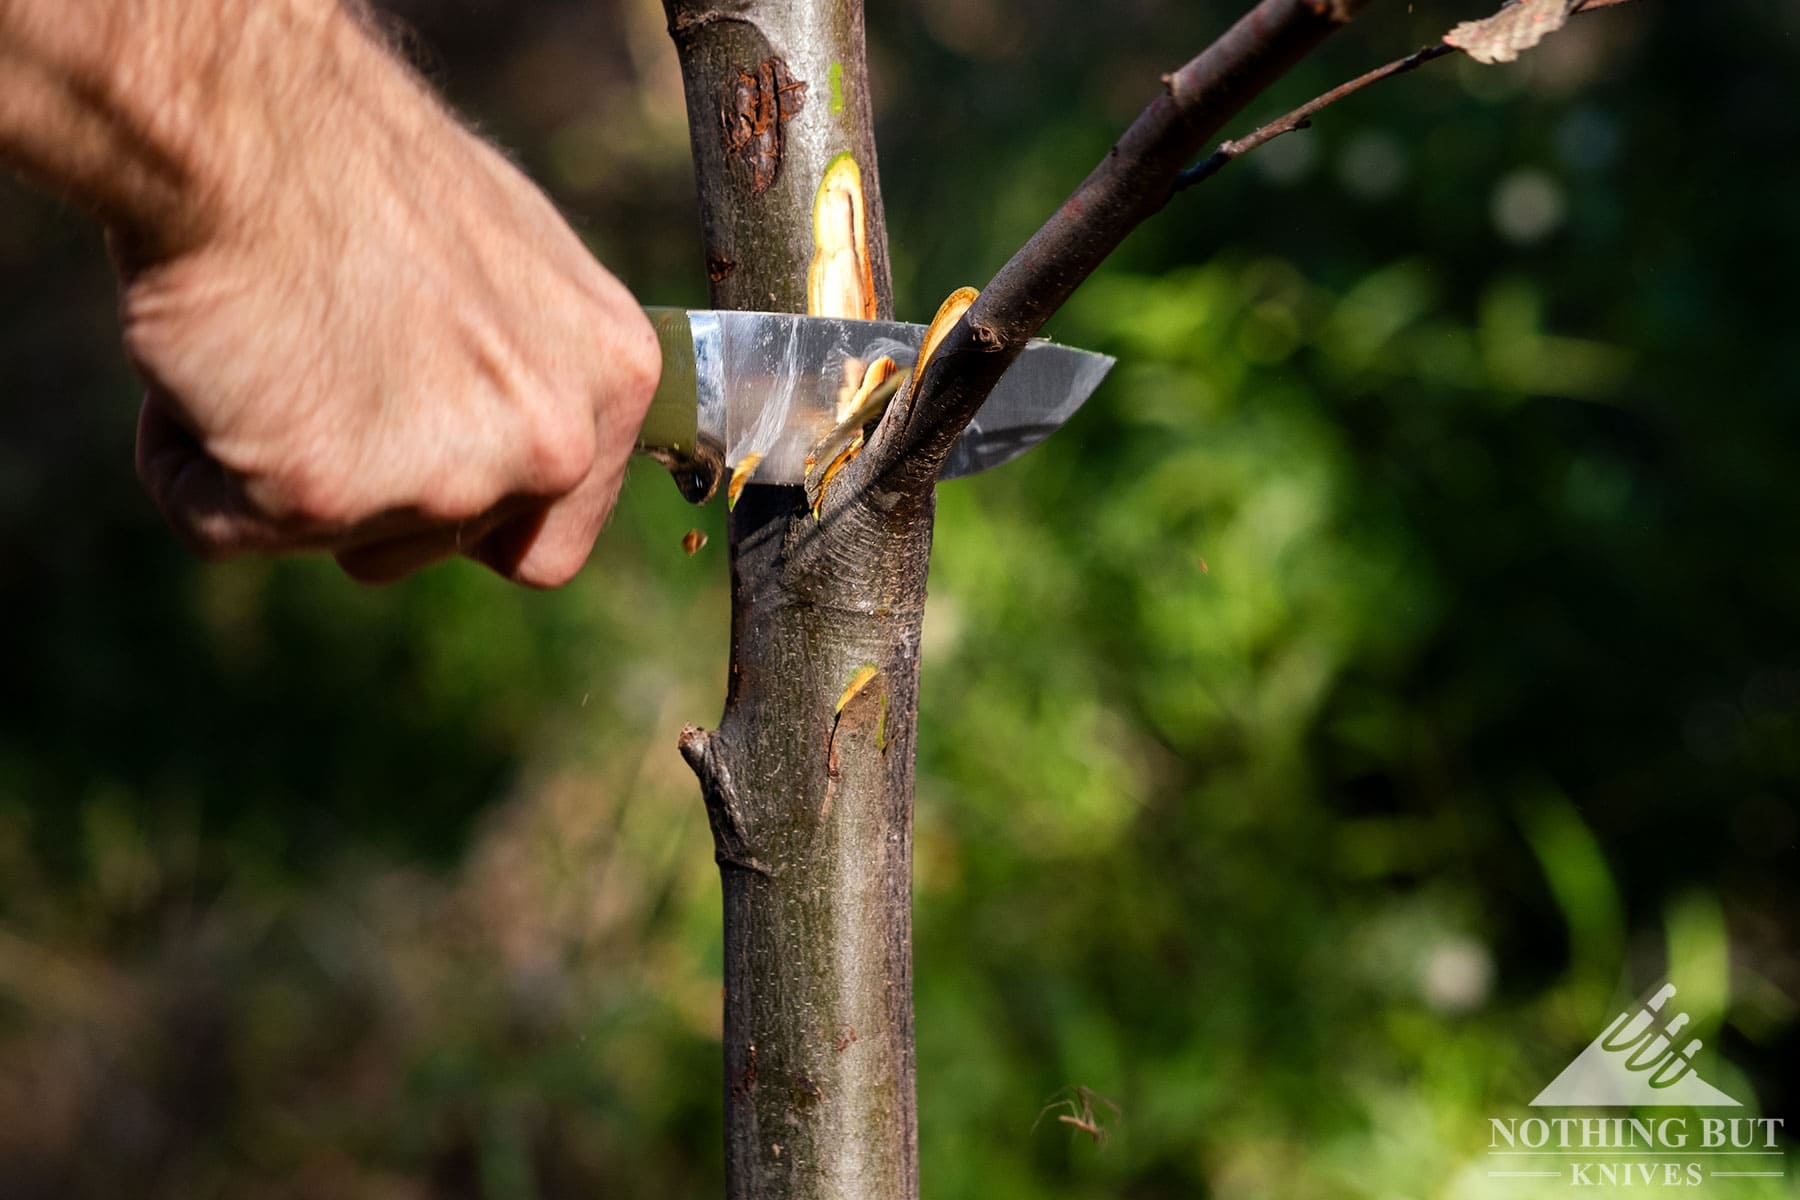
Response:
[137,392,277,560]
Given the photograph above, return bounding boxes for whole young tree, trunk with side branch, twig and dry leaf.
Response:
[664,0,1620,1200]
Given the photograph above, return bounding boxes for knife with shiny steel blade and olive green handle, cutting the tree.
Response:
[637,308,1112,504]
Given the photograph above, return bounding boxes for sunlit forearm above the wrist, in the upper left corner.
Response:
[0,0,390,254]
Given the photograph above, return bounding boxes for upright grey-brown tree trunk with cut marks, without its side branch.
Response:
[664,0,932,1200]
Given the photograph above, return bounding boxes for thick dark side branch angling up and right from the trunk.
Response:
[842,0,1370,496]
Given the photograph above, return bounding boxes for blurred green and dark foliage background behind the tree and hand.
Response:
[0,0,1800,1200]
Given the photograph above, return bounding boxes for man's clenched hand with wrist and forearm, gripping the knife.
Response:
[0,0,659,587]
